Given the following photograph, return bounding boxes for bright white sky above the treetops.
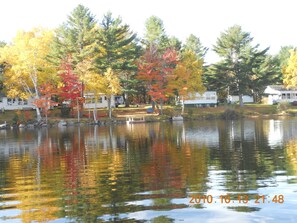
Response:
[0,0,297,61]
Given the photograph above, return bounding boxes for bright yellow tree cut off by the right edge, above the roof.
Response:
[283,50,297,88]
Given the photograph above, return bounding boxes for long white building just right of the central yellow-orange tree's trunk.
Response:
[183,91,218,107]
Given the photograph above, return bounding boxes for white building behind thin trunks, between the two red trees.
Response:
[84,93,124,109]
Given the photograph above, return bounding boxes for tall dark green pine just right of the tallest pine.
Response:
[95,13,141,106]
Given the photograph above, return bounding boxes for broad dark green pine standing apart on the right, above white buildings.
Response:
[206,25,275,106]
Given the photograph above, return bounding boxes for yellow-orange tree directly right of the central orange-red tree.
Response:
[174,50,205,113]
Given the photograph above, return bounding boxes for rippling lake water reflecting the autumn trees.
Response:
[0,119,297,223]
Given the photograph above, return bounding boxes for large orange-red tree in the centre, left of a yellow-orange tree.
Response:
[138,46,177,114]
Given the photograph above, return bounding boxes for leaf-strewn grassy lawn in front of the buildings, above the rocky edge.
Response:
[0,104,297,124]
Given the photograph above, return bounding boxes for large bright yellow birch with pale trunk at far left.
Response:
[0,28,57,121]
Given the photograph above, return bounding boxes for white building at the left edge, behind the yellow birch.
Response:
[0,95,35,111]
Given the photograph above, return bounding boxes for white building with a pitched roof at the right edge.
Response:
[264,85,297,105]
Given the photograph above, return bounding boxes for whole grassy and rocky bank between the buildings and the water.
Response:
[0,104,297,129]
